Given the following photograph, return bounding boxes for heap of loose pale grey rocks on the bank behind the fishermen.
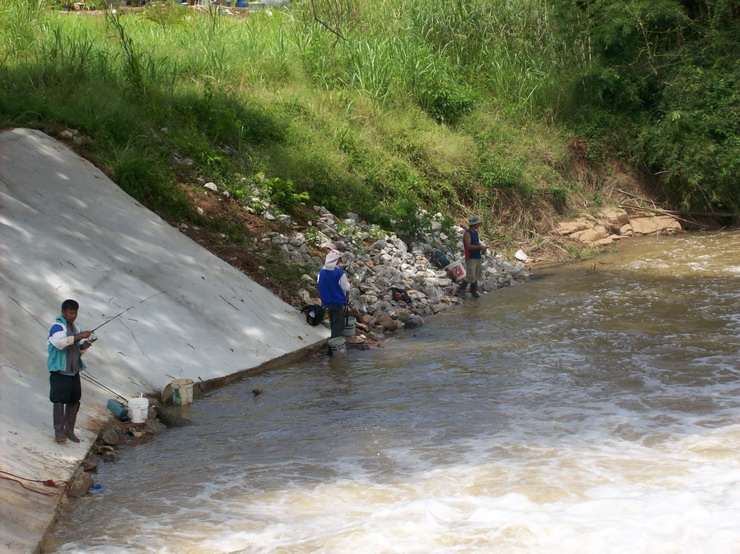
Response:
[195,195,529,326]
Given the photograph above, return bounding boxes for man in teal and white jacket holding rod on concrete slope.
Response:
[46,300,92,442]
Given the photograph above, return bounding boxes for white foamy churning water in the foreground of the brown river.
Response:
[53,425,740,554]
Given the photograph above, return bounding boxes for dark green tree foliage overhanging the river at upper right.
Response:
[560,0,740,212]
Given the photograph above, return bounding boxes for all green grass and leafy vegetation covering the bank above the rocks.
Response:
[0,0,740,247]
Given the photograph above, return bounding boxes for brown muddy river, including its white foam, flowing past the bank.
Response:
[47,232,740,554]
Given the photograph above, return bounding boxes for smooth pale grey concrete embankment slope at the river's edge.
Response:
[0,129,328,552]
